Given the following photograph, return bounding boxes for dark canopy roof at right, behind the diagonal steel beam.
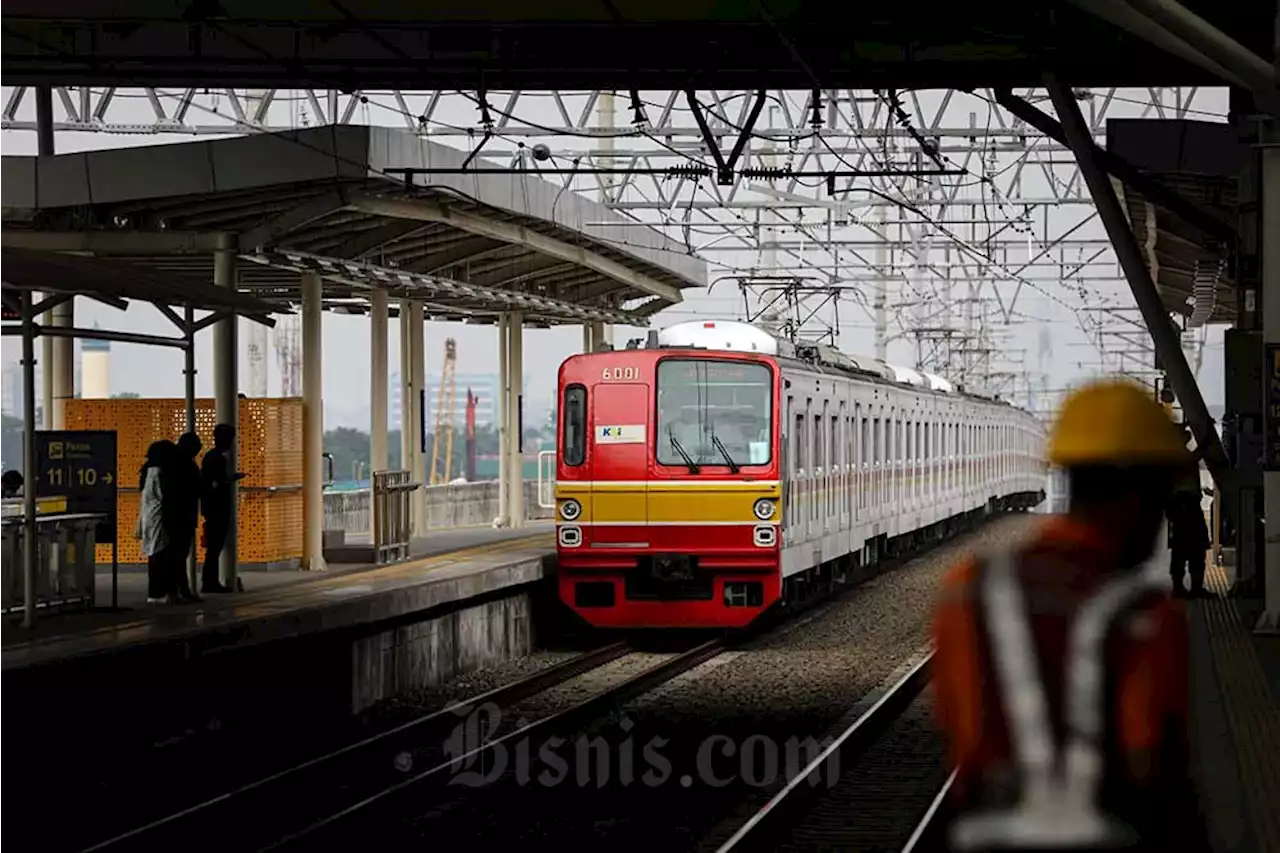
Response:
[1107,119,1248,328]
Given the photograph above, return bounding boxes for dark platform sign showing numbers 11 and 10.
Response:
[36,429,119,544]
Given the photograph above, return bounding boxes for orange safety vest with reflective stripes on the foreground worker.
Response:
[933,517,1207,849]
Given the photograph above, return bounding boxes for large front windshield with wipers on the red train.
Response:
[657,359,773,471]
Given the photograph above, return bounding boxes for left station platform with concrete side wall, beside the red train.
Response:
[0,521,556,768]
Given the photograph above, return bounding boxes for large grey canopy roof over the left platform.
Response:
[0,126,707,325]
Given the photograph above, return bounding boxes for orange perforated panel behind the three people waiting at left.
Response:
[65,398,303,566]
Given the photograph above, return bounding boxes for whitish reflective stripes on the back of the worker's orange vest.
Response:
[951,553,1156,849]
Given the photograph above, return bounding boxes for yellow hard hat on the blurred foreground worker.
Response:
[1048,379,1190,467]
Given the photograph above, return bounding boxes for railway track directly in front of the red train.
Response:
[82,638,731,853]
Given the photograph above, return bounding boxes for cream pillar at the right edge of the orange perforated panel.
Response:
[302,273,325,571]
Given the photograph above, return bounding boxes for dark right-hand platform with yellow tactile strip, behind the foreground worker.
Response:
[1188,558,1280,853]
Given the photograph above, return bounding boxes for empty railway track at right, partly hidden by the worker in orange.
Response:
[700,652,950,853]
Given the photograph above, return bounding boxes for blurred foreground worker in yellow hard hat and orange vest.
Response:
[933,380,1210,850]
